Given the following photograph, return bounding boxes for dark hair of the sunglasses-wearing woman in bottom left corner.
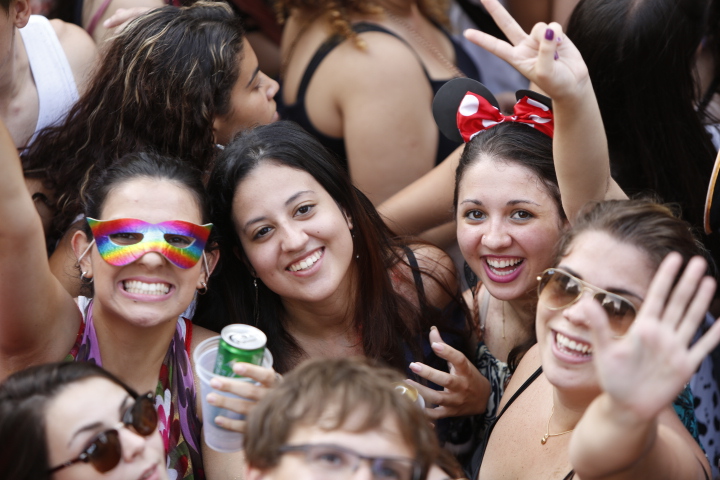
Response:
[0,362,137,480]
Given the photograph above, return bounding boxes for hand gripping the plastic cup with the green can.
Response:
[206,362,282,433]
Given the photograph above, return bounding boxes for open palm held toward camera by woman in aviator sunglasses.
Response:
[587,253,720,421]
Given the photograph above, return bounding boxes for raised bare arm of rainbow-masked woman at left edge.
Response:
[0,118,81,378]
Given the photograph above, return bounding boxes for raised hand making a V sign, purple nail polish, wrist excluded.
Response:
[465,0,590,99]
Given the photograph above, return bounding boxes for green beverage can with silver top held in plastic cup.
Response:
[213,323,267,378]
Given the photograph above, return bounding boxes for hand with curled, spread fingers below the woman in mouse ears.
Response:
[407,327,490,420]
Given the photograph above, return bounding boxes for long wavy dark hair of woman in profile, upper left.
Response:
[23,1,244,246]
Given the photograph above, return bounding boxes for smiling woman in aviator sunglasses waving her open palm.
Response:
[473,200,720,480]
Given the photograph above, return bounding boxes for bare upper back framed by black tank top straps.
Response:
[330,32,439,205]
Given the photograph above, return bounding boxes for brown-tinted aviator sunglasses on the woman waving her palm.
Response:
[537,268,637,334]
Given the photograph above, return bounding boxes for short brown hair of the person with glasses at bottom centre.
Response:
[245,358,440,478]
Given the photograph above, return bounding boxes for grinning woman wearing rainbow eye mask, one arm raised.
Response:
[0,118,275,479]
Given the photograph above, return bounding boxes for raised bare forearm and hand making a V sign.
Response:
[465,0,625,220]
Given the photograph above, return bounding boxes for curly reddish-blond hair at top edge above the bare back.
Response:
[275,0,450,50]
